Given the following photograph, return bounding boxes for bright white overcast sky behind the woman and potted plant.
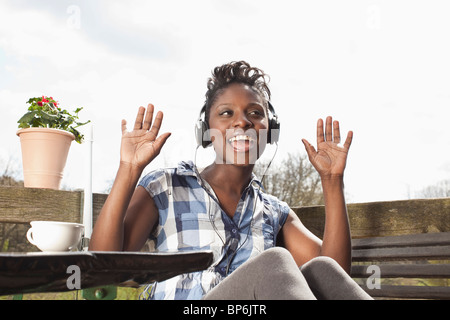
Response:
[0,0,450,202]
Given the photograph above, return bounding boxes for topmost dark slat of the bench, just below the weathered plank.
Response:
[352,232,450,250]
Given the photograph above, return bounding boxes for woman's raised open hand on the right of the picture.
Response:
[302,117,353,179]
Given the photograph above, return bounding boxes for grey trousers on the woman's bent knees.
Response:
[204,247,372,300]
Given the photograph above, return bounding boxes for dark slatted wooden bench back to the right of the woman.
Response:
[351,232,450,299]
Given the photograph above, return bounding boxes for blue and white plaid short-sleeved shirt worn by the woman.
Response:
[139,161,289,300]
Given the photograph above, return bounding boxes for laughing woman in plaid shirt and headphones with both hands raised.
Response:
[90,61,370,299]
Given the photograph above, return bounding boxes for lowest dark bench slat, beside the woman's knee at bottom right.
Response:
[362,285,450,300]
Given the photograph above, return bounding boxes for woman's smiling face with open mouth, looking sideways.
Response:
[209,83,268,165]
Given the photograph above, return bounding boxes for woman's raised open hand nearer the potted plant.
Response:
[120,104,170,169]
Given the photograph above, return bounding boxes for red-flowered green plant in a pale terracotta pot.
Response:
[17,96,90,189]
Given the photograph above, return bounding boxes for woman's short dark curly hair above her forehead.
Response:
[205,61,271,122]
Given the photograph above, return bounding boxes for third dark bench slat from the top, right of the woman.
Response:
[351,264,450,278]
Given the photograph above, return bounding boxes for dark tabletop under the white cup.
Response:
[0,251,213,295]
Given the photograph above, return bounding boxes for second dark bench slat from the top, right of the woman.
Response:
[352,245,450,261]
